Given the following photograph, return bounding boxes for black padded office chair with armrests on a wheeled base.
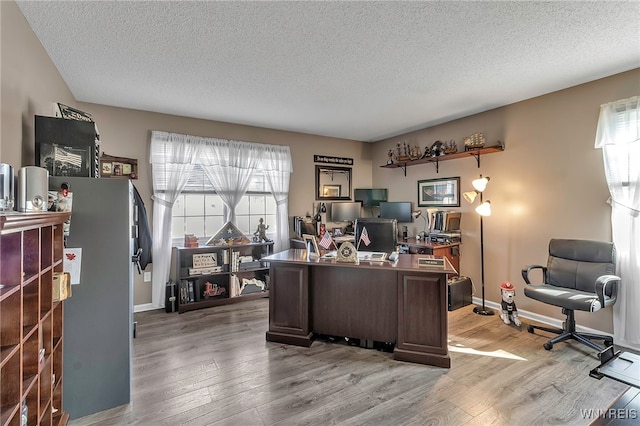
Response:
[522,239,620,352]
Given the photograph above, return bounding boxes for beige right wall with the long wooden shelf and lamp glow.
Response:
[373,69,640,332]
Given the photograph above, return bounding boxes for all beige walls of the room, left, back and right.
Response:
[5,1,640,331]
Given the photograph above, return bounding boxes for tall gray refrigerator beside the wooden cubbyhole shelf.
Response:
[49,177,136,419]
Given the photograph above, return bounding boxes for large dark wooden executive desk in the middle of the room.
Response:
[263,249,456,368]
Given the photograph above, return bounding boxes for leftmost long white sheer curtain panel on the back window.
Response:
[150,131,201,307]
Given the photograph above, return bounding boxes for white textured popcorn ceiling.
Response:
[17,0,640,141]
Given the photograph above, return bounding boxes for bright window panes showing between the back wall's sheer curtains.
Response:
[171,165,276,244]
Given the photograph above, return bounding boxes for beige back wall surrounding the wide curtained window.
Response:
[78,103,372,305]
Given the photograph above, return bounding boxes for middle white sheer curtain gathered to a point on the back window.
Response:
[198,139,265,223]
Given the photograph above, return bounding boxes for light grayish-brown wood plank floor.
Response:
[70,299,628,426]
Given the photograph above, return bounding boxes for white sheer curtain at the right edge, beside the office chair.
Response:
[595,96,640,349]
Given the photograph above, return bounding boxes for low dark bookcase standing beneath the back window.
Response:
[169,242,273,313]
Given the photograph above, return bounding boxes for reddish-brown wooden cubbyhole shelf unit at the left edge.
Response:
[0,213,69,426]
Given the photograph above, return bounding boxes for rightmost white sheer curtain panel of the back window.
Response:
[262,146,293,253]
